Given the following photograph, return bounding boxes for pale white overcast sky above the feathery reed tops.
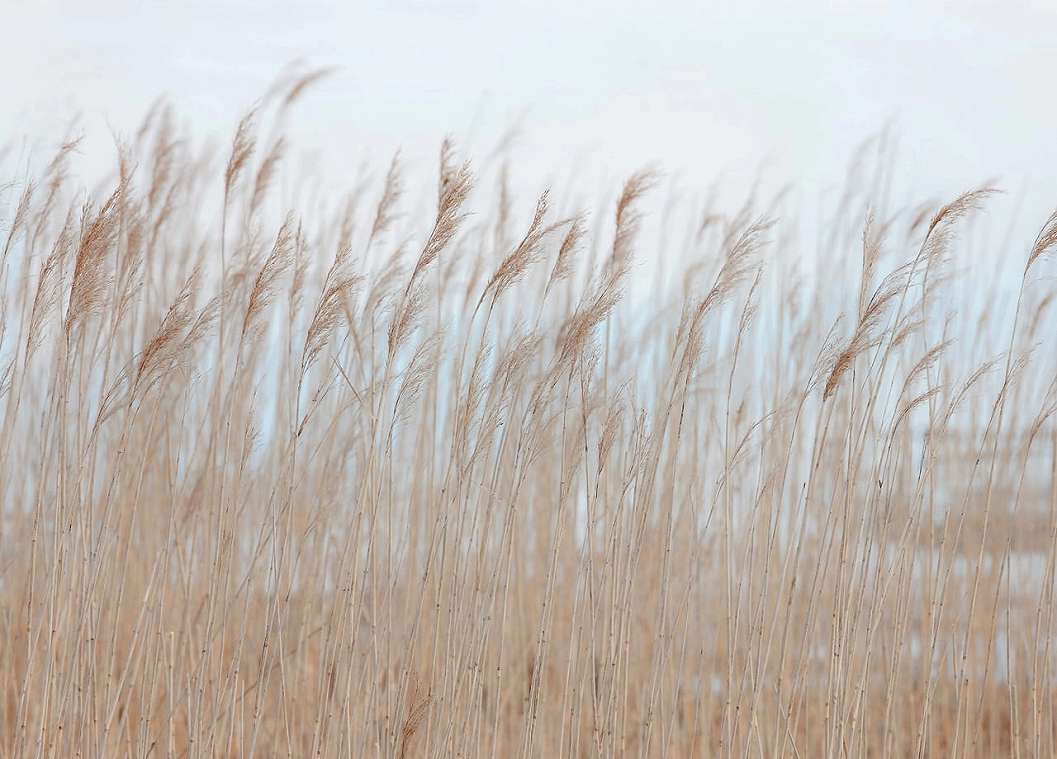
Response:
[0,0,1057,236]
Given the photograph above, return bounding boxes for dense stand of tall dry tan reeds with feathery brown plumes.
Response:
[0,86,1057,757]
